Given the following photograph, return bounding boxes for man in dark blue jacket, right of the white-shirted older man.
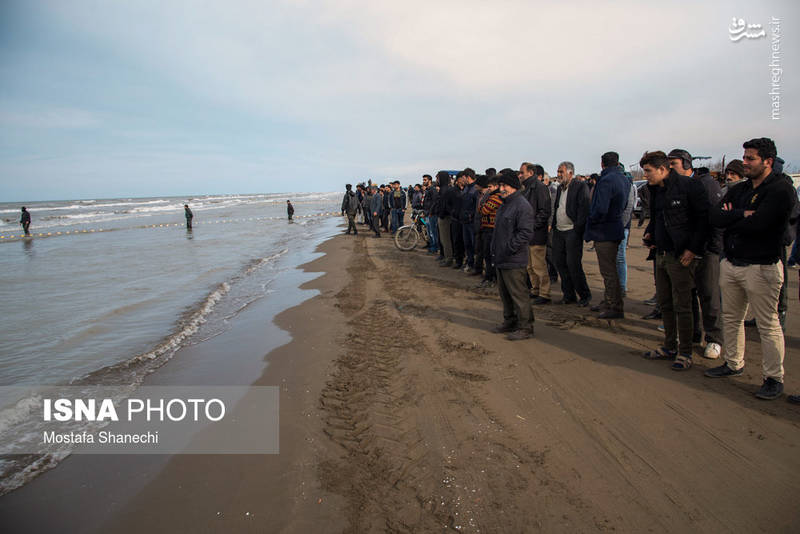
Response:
[584,152,632,319]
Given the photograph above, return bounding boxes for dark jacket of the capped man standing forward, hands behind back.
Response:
[491,191,536,269]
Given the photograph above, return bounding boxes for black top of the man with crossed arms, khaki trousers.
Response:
[710,172,796,265]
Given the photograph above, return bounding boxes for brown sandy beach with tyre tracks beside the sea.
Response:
[0,224,800,532]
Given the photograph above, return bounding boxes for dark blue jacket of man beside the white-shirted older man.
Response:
[583,167,631,241]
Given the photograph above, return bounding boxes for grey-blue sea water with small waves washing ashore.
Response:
[0,193,342,494]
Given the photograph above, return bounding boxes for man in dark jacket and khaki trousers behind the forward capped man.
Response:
[519,162,552,304]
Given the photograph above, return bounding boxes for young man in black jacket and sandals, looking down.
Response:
[639,151,709,371]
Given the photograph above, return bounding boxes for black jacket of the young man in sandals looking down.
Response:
[644,170,711,257]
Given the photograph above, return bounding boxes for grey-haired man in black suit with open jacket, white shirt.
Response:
[553,161,592,307]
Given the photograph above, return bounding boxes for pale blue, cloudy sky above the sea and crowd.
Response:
[0,0,800,201]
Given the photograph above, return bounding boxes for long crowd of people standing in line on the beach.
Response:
[342,138,800,404]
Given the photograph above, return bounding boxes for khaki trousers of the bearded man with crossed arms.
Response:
[719,259,784,382]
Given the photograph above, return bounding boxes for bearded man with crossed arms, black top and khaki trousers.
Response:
[705,137,795,400]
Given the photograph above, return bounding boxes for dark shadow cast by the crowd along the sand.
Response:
[370,234,800,423]
